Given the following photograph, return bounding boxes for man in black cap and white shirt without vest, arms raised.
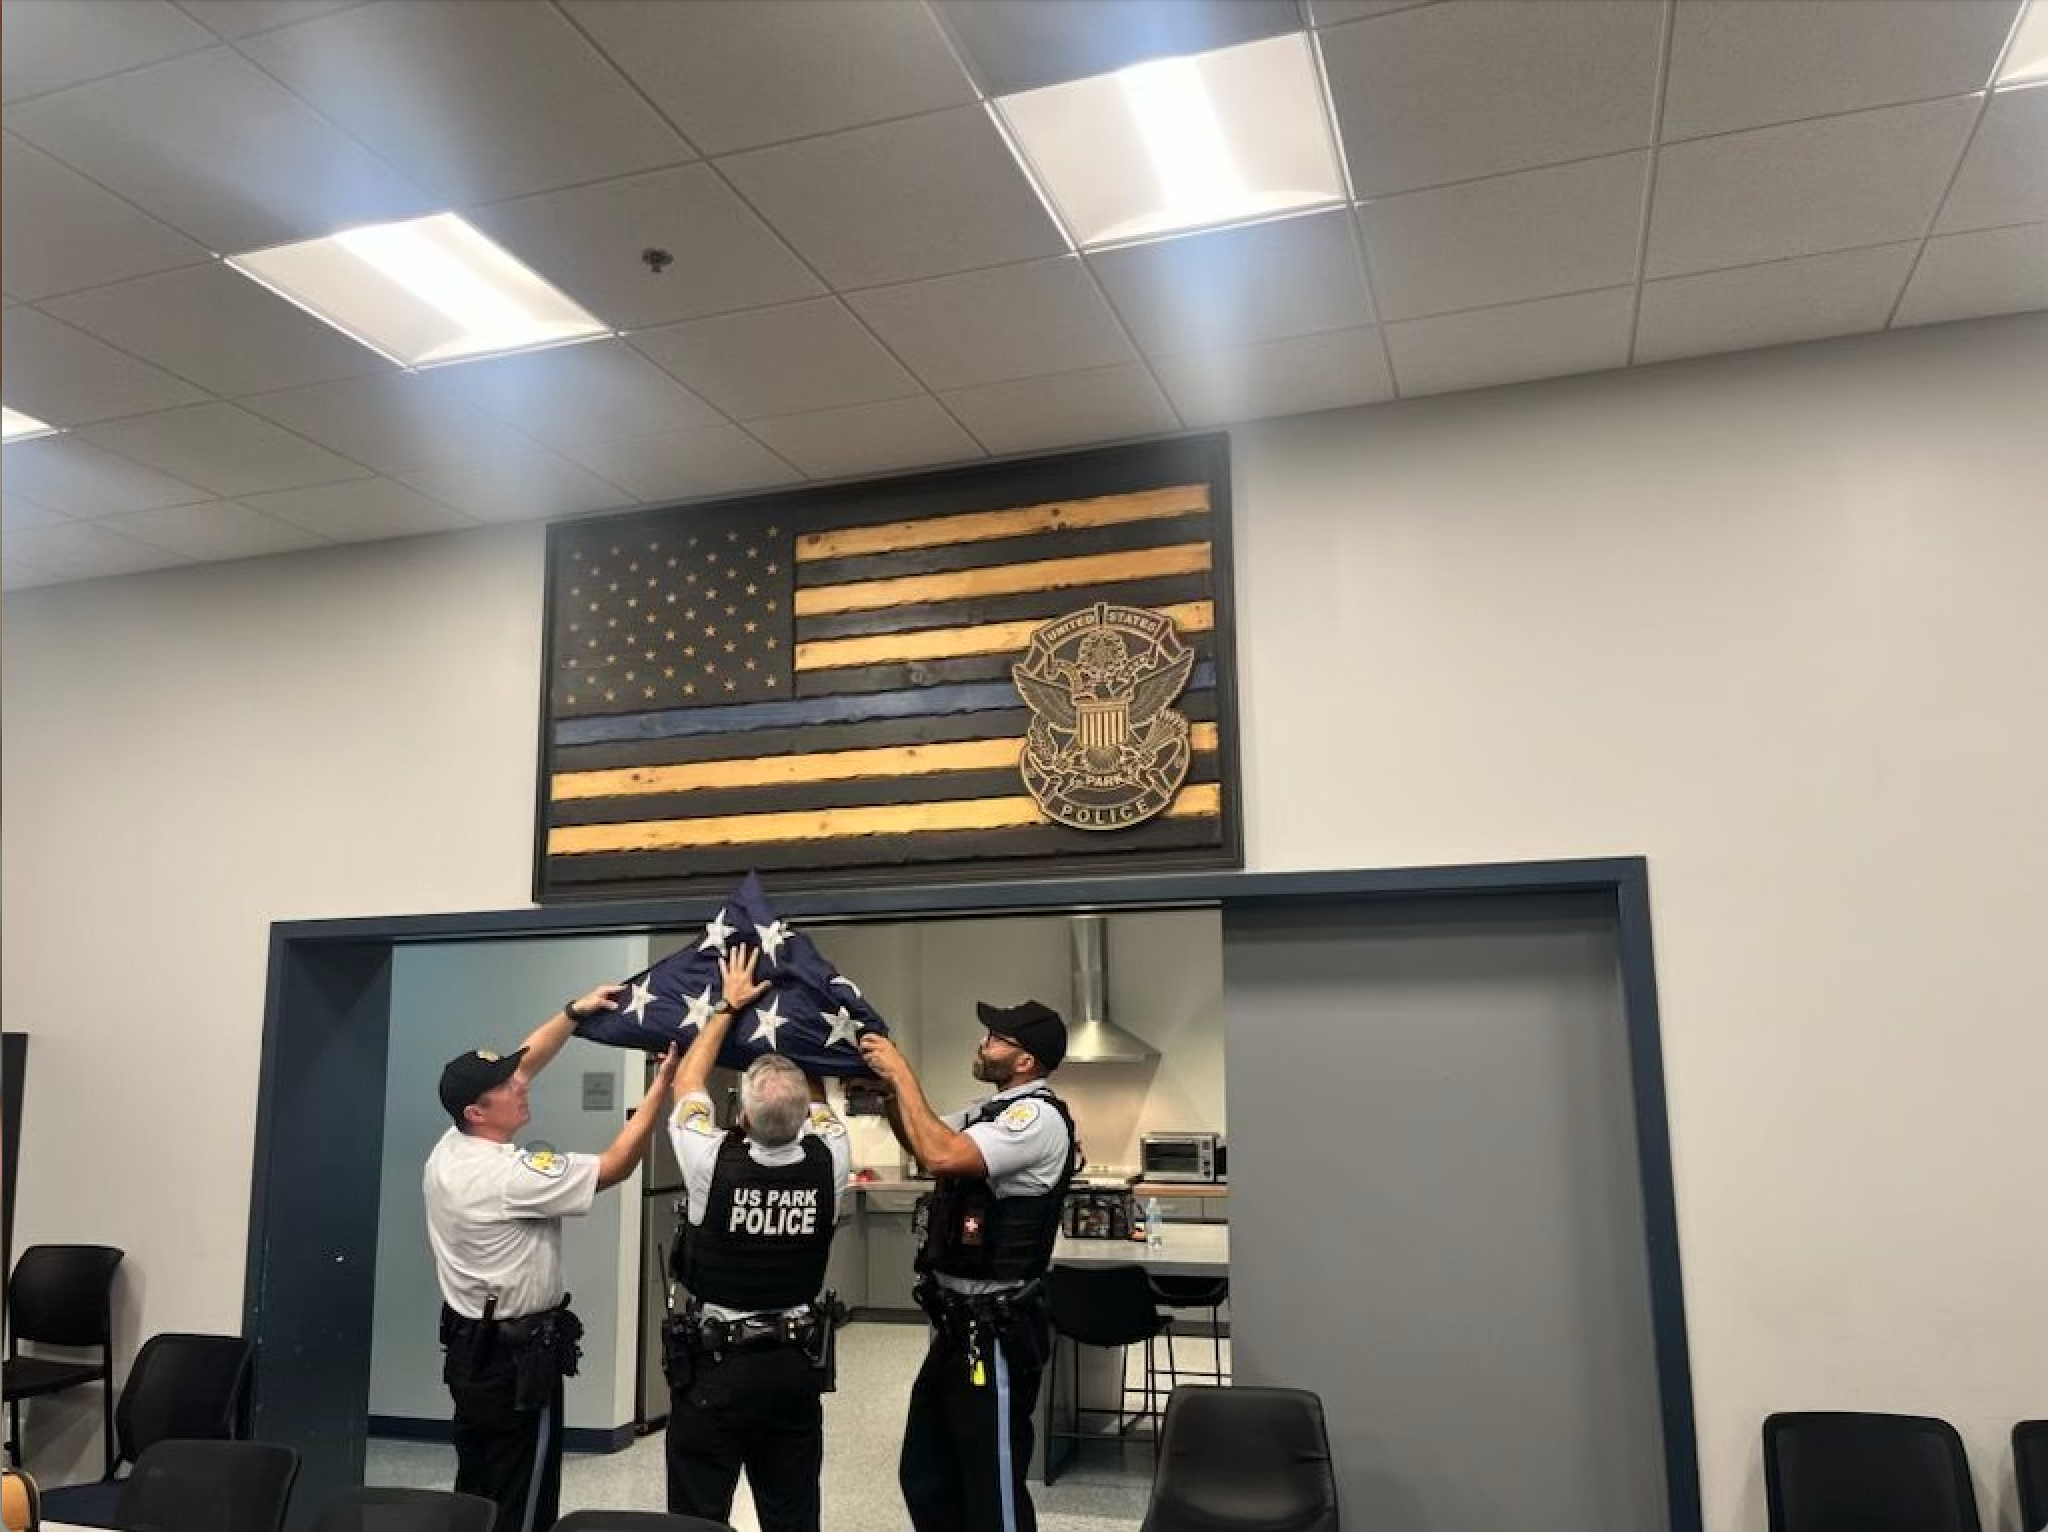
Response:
[422,985,678,1532]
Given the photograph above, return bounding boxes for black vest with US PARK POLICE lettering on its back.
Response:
[680,1129,834,1309]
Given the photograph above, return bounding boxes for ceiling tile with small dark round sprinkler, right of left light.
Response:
[471,164,825,330]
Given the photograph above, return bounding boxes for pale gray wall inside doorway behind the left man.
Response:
[371,936,647,1430]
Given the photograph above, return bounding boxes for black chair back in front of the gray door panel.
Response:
[1139,1382,1337,1532]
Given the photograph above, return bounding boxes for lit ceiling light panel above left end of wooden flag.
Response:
[227,213,610,367]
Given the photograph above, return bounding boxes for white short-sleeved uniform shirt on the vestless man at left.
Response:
[422,1129,598,1319]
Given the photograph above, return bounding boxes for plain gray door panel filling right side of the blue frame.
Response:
[1223,899,1667,1532]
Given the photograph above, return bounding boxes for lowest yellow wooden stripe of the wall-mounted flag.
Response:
[547,782,1223,856]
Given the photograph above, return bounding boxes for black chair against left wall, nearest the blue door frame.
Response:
[43,1333,252,1526]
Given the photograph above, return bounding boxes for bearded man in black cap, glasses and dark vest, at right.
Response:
[860,999,1079,1532]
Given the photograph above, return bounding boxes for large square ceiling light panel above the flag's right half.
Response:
[993,33,1346,250]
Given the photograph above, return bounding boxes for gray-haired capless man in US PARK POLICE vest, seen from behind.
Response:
[662,946,852,1532]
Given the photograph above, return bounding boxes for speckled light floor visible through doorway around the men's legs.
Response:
[367,1323,1229,1532]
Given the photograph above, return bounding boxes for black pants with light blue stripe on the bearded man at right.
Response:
[897,1321,1047,1532]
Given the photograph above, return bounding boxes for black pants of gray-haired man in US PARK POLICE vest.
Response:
[668,1346,825,1532]
